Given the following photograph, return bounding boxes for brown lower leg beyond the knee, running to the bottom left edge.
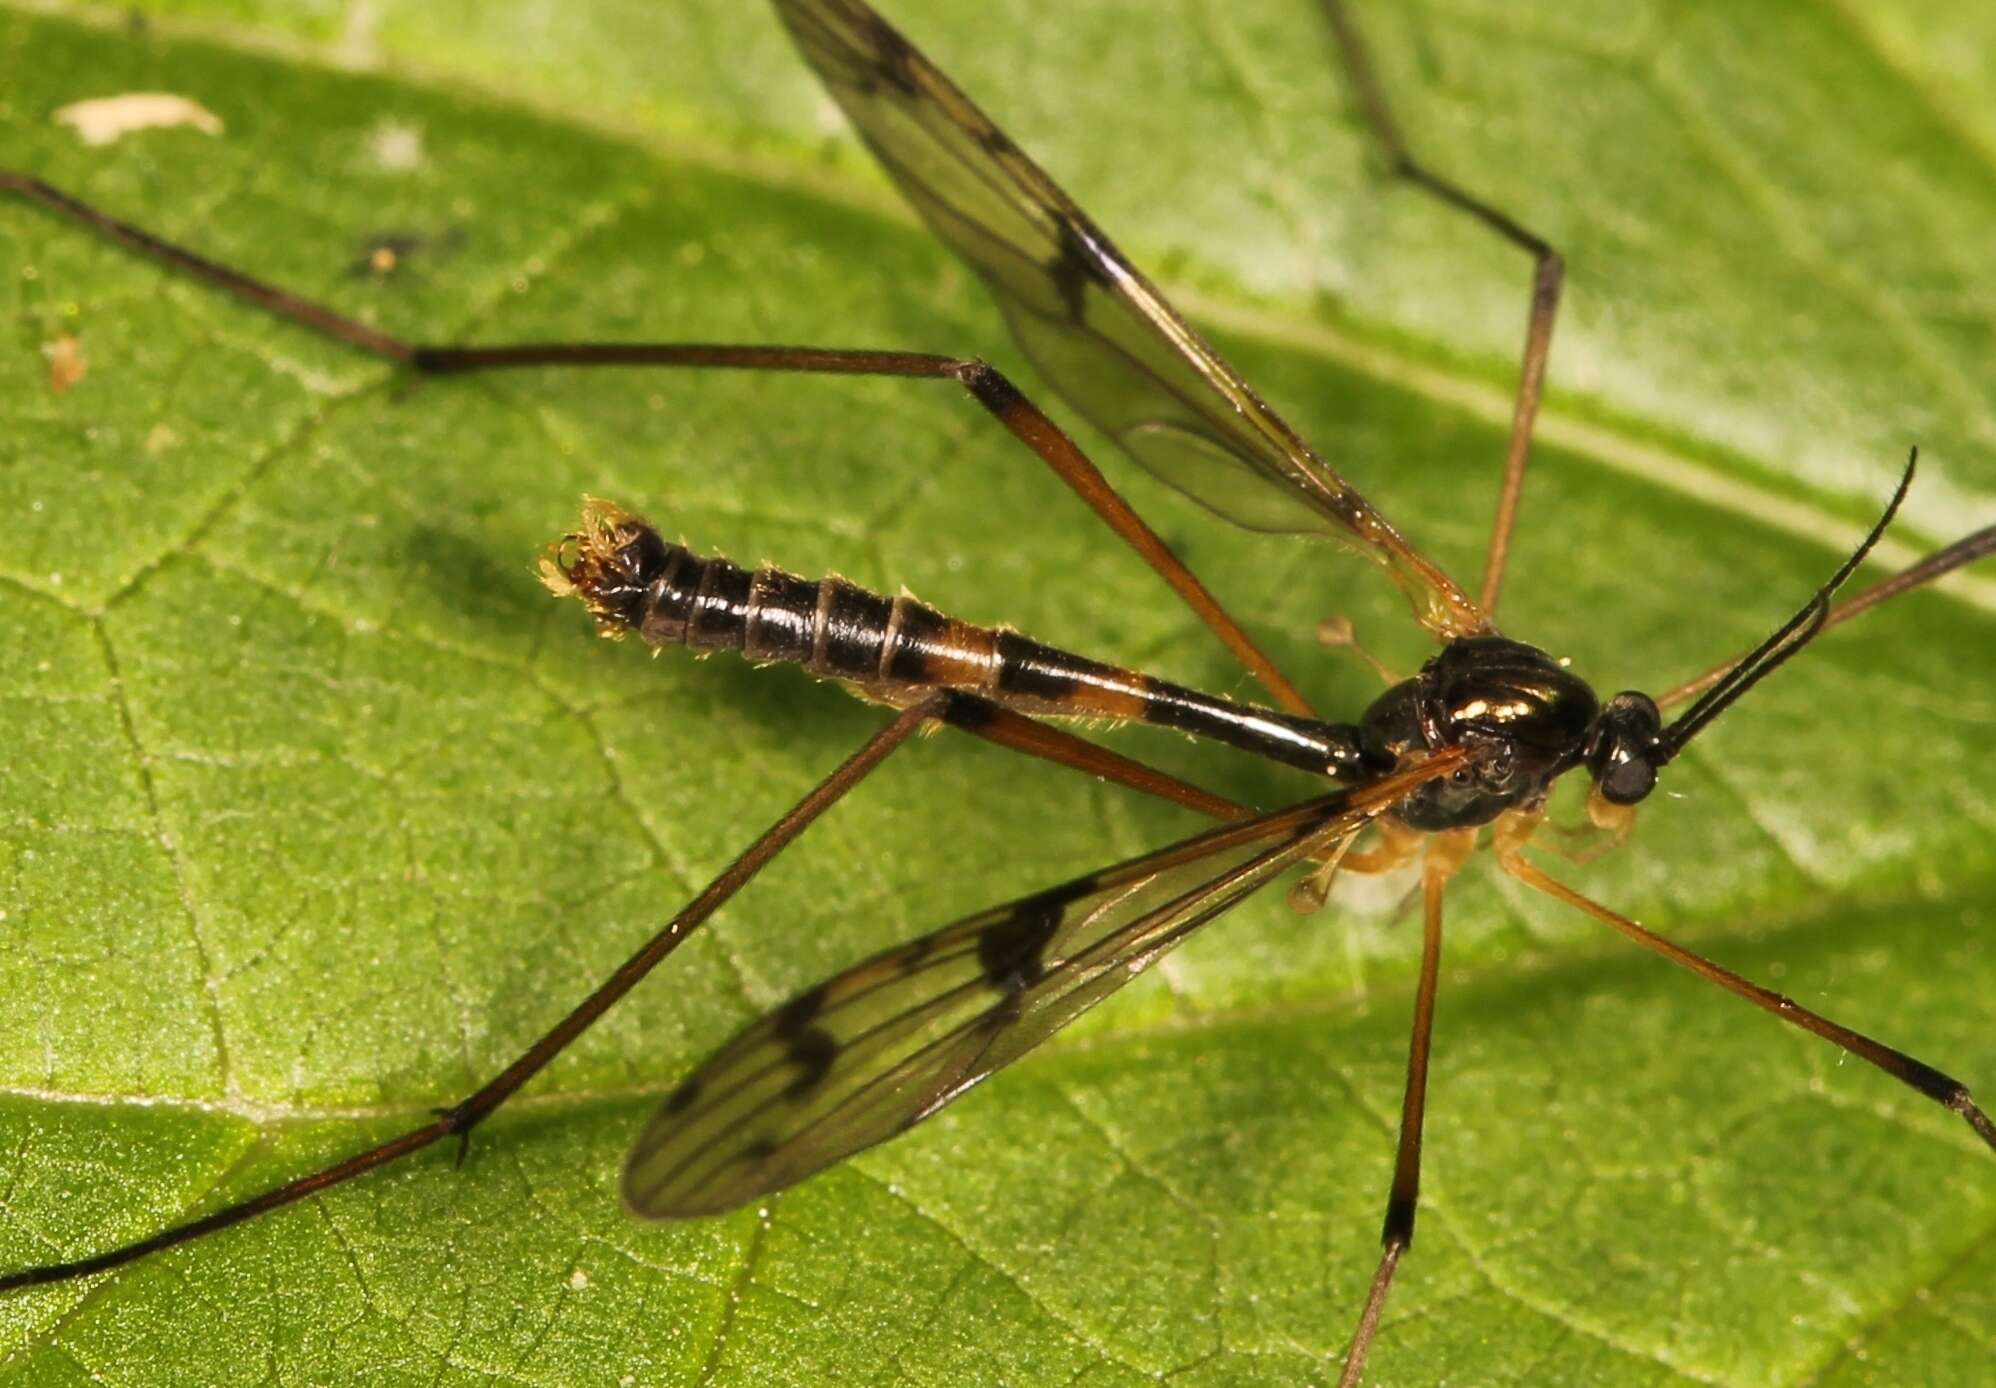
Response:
[0,701,940,1292]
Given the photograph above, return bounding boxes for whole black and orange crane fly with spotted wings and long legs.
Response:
[0,0,1996,1384]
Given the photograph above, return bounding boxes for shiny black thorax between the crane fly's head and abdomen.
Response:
[1359,637,1601,831]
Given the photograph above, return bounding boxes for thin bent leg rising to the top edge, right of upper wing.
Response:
[1323,0,1567,615]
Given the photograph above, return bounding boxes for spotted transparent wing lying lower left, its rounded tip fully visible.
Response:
[623,751,1463,1218]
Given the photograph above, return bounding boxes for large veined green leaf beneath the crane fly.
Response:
[0,0,1996,1386]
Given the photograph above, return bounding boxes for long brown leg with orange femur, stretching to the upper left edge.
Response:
[0,170,1311,717]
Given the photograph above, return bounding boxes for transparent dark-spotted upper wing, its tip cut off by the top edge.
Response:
[774,0,1489,637]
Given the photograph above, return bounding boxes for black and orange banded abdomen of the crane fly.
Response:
[541,501,1359,775]
